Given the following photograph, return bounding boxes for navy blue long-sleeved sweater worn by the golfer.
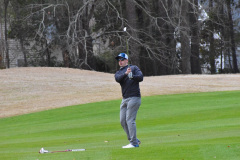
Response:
[115,65,143,98]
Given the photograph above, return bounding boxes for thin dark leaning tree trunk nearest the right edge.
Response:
[227,0,239,73]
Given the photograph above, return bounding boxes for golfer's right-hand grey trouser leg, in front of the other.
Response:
[126,97,141,145]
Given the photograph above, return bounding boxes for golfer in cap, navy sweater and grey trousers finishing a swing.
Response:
[115,53,143,148]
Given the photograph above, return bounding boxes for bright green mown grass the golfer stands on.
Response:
[0,91,240,160]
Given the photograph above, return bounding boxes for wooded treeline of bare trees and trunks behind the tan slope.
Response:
[0,0,240,76]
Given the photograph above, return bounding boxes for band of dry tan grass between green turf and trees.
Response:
[0,67,240,118]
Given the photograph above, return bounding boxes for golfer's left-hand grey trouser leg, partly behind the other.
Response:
[120,99,130,140]
